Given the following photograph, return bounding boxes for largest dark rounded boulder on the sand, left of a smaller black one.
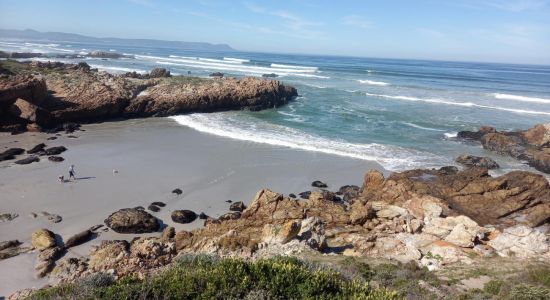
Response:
[105,208,160,233]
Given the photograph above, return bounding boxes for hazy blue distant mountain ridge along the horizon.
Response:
[0,29,235,51]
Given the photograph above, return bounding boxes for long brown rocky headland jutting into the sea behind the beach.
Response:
[0,60,297,131]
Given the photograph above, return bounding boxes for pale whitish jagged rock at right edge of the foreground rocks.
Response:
[489,225,550,258]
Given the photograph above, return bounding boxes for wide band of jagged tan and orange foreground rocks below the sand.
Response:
[2,163,550,299]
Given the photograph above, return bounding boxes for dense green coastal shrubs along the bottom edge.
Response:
[25,256,400,299]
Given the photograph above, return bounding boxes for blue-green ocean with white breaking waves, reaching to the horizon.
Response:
[0,40,550,172]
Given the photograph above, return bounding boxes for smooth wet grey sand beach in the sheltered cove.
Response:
[0,118,387,295]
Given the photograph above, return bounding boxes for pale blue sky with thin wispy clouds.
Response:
[0,0,550,65]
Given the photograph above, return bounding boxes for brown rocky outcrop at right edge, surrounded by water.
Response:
[457,123,550,173]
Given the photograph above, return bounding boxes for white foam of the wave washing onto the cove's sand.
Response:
[170,113,441,170]
